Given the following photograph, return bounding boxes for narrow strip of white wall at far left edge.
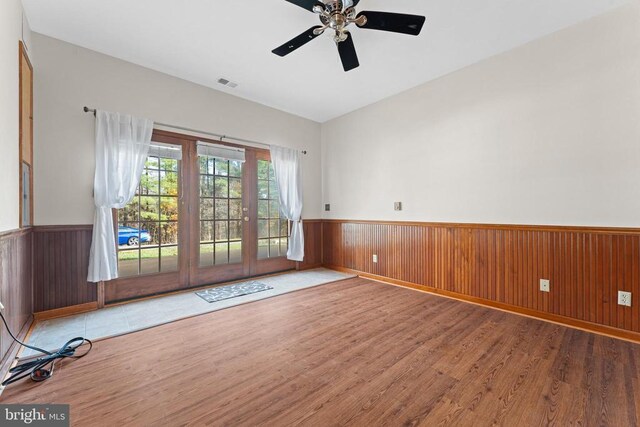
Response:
[0,0,29,232]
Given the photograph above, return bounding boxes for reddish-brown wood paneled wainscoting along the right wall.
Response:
[322,220,640,341]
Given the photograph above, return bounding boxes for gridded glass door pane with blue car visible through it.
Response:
[118,156,180,277]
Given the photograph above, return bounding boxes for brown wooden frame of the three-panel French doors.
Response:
[104,129,296,304]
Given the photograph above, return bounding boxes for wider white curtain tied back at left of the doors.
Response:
[87,111,153,282]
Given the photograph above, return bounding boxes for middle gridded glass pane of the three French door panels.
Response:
[198,156,243,267]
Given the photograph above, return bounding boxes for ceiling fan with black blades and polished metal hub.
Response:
[272,0,425,71]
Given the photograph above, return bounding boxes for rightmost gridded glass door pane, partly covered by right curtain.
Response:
[258,160,289,259]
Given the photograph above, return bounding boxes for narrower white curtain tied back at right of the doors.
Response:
[271,146,304,261]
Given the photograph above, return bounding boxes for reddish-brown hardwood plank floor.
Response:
[2,279,640,426]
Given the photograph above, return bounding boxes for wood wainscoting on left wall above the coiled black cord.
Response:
[0,228,33,375]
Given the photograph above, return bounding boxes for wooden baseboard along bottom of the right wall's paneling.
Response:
[324,265,640,343]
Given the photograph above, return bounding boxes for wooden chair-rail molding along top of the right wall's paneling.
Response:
[322,219,640,235]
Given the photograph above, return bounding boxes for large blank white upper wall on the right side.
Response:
[322,2,640,227]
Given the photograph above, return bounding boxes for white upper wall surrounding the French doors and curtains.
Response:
[32,33,321,225]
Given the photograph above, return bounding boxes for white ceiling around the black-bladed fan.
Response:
[22,0,627,122]
